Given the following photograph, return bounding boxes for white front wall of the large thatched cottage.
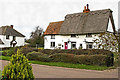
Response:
[44,34,98,49]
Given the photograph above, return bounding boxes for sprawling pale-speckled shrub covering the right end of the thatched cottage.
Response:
[94,32,118,52]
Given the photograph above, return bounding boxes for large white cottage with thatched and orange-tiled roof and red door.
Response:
[44,4,115,49]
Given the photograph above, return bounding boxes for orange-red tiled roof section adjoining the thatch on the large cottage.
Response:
[44,21,63,35]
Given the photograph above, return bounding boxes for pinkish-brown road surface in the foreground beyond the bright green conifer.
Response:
[0,60,118,78]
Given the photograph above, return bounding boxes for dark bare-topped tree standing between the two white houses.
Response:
[26,26,44,47]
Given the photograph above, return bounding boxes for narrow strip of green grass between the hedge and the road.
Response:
[0,56,109,70]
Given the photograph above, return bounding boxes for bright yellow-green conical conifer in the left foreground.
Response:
[2,49,34,80]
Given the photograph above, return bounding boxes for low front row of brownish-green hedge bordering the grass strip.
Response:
[26,52,112,66]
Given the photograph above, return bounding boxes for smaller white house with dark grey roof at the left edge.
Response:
[0,25,25,48]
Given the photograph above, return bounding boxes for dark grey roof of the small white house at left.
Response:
[0,26,25,37]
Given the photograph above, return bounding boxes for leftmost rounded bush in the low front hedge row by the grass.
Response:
[26,51,51,62]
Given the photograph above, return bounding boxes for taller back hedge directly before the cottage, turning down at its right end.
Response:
[39,49,114,66]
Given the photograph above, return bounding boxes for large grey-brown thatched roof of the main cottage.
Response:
[59,9,115,34]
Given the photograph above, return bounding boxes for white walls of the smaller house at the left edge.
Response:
[0,35,25,48]
